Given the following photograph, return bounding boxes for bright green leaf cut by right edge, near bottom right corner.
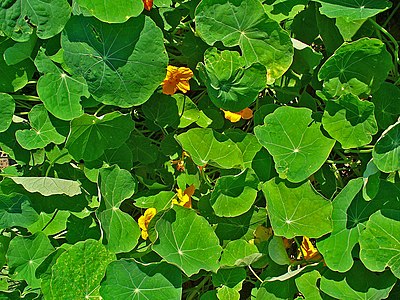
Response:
[360,210,400,278]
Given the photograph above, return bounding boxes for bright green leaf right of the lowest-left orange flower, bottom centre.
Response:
[153,205,222,276]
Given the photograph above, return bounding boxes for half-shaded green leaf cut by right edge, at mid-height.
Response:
[372,119,400,173]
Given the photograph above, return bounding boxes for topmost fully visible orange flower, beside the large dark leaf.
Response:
[161,66,193,95]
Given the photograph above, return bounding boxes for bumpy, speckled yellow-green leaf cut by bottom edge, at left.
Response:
[43,240,115,299]
